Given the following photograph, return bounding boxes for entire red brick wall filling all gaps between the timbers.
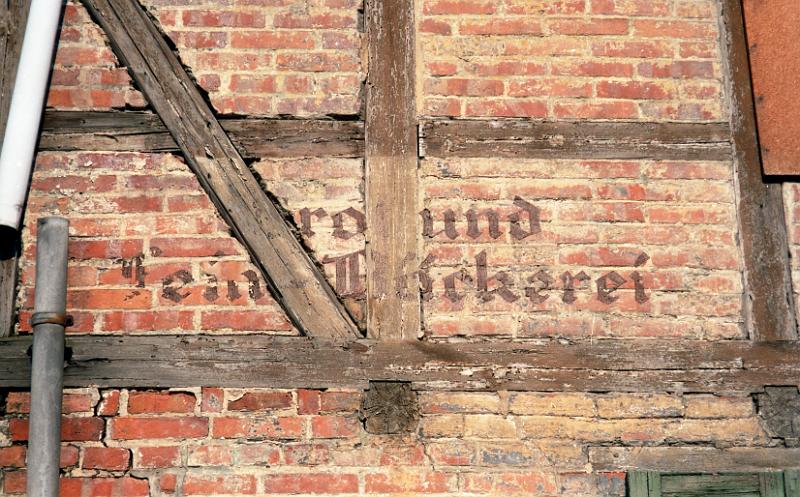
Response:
[0,0,788,497]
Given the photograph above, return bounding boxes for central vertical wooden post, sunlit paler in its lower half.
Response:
[365,0,420,340]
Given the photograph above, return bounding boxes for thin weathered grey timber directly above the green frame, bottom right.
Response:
[589,447,800,473]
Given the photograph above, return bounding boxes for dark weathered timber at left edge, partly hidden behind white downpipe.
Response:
[0,0,30,337]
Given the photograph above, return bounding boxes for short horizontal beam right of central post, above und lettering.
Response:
[420,120,732,160]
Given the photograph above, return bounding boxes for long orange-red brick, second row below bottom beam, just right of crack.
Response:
[111,417,208,440]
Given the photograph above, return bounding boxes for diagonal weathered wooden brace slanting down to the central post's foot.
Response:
[83,0,360,338]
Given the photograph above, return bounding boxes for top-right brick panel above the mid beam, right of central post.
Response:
[417,0,726,121]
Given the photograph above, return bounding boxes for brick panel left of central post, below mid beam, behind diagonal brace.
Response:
[14,153,365,334]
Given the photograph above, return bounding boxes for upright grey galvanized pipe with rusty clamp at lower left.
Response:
[28,217,69,497]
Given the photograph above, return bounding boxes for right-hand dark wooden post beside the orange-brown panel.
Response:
[722,0,797,341]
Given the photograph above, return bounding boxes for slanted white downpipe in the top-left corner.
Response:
[0,0,64,229]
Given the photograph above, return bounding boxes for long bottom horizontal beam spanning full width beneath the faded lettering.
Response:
[0,335,800,394]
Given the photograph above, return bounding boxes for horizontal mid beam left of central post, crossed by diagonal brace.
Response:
[39,110,364,159]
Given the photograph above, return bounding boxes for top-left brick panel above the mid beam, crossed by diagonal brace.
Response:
[48,0,363,116]
